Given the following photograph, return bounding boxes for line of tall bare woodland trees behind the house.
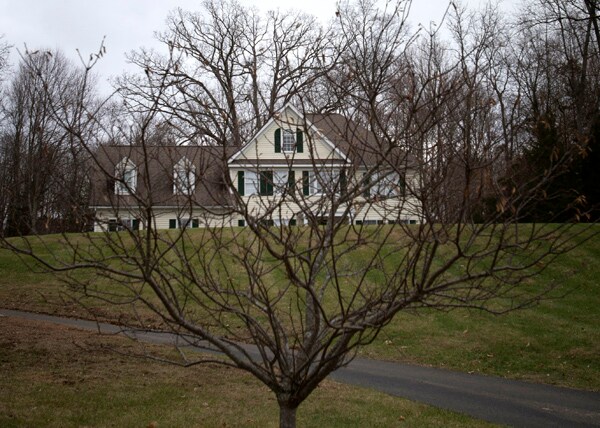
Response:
[0,0,600,235]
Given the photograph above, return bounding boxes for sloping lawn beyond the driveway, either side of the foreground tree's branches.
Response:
[0,226,600,390]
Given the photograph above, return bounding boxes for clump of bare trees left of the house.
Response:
[1,50,102,235]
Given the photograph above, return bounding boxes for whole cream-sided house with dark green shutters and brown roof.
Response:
[92,104,421,231]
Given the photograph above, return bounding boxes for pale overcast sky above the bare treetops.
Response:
[0,0,514,92]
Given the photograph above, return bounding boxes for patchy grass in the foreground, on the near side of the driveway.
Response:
[0,317,491,428]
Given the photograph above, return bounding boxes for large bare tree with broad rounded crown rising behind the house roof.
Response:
[121,0,331,147]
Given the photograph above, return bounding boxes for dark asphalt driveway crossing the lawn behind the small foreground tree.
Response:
[0,309,600,427]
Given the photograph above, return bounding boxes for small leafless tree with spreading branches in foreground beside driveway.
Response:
[2,1,597,427]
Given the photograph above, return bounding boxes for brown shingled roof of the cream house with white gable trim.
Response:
[90,105,415,207]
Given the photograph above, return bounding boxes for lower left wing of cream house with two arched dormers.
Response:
[91,145,232,232]
